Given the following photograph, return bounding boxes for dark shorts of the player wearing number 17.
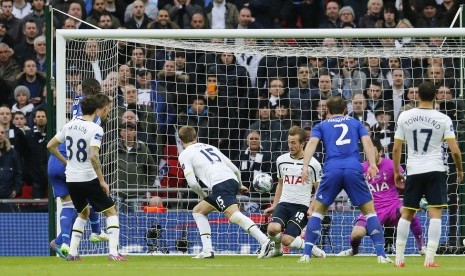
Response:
[404,172,447,210]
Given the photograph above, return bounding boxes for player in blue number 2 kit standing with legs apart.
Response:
[299,97,392,263]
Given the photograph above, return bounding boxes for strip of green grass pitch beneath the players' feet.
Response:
[0,255,465,276]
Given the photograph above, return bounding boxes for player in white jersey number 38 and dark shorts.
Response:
[47,94,126,261]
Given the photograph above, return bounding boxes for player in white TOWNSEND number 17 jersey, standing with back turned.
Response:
[393,82,463,267]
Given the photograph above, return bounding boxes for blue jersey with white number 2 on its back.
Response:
[312,116,368,171]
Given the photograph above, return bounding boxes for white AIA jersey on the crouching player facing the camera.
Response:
[276,153,321,206]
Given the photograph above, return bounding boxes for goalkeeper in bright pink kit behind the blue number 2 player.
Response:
[337,140,425,256]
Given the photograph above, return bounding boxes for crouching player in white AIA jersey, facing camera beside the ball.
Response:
[264,126,326,258]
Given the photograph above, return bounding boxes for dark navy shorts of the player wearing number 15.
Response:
[204,179,239,212]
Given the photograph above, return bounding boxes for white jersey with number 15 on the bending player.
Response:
[179,143,238,189]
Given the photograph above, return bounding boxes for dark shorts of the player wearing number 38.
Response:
[67,178,115,213]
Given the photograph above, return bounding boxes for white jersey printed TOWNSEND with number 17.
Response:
[394,108,455,175]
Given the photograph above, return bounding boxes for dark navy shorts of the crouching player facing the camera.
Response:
[271,202,308,237]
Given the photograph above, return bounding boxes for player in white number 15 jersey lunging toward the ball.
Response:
[179,126,274,259]
